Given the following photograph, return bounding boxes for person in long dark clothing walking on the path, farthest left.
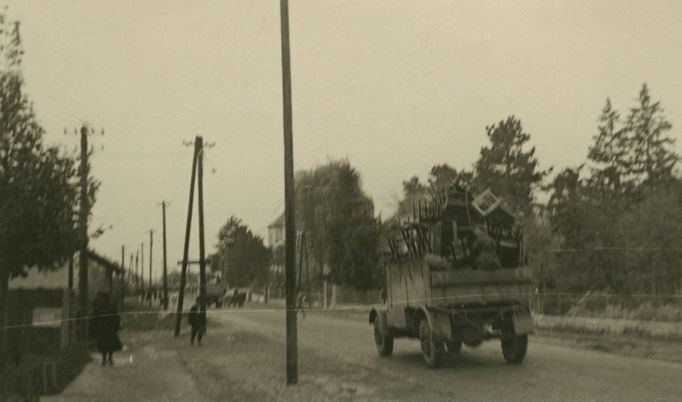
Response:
[92,292,123,366]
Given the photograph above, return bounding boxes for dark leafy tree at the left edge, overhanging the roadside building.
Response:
[0,12,85,358]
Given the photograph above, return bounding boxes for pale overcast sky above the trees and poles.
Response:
[2,0,682,280]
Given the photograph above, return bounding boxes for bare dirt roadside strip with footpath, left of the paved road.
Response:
[41,306,436,402]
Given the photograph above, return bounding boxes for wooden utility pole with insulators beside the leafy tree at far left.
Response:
[78,124,90,342]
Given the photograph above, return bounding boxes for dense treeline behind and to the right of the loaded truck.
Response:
[397,85,682,312]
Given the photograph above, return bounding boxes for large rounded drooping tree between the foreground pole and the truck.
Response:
[296,160,383,289]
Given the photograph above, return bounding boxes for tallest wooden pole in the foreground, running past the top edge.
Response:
[279,0,298,385]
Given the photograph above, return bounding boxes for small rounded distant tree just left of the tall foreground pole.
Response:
[211,216,272,286]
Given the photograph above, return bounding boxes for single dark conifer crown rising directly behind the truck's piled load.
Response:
[474,116,547,216]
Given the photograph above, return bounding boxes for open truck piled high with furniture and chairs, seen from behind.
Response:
[369,184,533,367]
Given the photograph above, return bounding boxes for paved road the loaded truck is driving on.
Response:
[211,309,682,401]
